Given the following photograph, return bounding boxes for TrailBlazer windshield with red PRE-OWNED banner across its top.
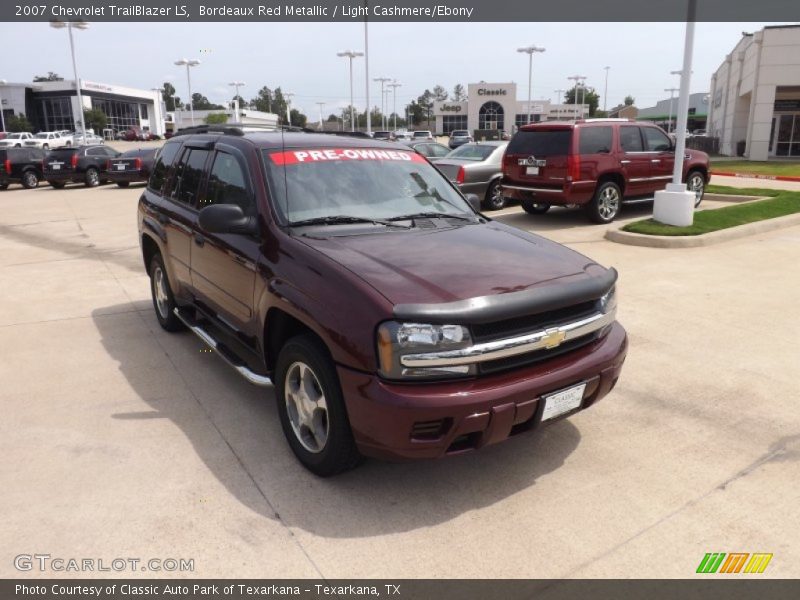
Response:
[264,148,474,224]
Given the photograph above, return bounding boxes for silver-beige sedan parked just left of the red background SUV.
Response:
[436,142,508,210]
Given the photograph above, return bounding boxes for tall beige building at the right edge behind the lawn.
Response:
[707,25,800,160]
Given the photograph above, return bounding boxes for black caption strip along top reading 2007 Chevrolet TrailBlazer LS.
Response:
[0,0,800,23]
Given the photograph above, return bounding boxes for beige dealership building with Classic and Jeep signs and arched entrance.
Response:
[432,81,589,134]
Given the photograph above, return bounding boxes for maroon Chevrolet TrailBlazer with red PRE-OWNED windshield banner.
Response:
[137,128,627,476]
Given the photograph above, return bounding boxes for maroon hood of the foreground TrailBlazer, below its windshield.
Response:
[296,222,605,304]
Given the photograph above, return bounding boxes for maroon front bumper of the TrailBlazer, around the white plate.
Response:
[337,323,628,460]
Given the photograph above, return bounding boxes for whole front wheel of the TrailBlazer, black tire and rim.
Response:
[275,334,361,477]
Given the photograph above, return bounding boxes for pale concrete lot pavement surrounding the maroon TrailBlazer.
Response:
[0,186,800,578]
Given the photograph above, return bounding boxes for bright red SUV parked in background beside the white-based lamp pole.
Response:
[501,119,709,223]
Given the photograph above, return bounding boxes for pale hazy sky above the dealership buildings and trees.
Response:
[0,21,788,120]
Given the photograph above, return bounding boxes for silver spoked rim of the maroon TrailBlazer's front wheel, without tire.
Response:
[283,361,329,454]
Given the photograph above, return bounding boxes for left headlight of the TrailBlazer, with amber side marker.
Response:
[377,321,475,379]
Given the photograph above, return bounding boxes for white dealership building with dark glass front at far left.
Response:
[0,79,165,135]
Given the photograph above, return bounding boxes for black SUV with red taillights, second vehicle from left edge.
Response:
[44,146,119,188]
